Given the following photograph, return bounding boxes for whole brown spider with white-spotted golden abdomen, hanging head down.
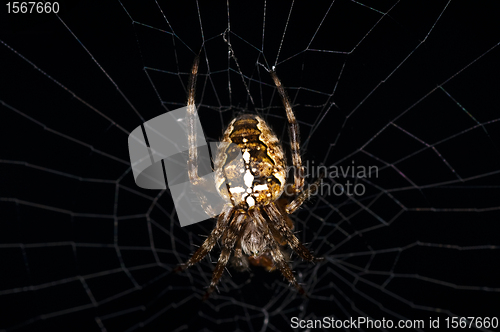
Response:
[175,55,323,300]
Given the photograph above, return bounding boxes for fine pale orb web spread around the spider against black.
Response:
[0,0,500,331]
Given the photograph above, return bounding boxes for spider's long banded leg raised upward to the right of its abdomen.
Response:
[270,70,304,193]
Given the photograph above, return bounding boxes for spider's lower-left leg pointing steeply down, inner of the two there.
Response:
[203,214,248,301]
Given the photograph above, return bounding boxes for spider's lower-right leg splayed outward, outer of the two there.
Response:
[264,203,324,262]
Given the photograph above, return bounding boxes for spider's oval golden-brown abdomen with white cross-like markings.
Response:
[215,114,286,209]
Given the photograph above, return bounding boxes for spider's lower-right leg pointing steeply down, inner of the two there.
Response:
[248,209,306,295]
